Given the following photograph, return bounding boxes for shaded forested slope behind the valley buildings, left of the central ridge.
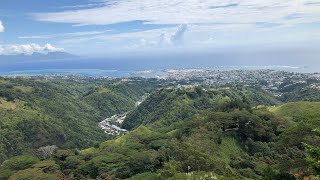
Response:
[83,78,161,117]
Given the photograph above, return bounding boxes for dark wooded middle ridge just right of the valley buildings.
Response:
[123,86,277,129]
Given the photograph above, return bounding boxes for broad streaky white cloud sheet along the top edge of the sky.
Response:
[34,0,320,25]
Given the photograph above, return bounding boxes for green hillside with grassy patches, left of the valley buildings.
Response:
[0,78,158,162]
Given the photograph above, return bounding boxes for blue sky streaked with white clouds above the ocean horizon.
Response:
[0,0,320,56]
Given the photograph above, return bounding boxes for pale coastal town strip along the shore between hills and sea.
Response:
[0,69,320,97]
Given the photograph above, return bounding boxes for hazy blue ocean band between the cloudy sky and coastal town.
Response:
[0,49,320,76]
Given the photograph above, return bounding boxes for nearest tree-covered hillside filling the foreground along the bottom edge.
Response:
[0,102,320,180]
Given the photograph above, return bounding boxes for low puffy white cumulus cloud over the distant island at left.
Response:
[0,44,64,55]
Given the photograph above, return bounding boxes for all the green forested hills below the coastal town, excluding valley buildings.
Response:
[0,78,320,180]
